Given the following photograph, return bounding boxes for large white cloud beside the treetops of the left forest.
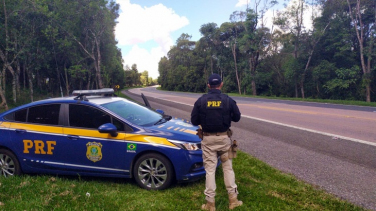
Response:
[115,0,189,79]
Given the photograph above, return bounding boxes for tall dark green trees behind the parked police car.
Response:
[0,0,148,109]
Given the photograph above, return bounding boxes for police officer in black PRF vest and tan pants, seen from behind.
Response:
[191,74,243,211]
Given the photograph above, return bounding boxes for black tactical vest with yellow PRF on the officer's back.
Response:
[200,94,231,133]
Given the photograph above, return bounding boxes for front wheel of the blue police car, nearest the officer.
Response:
[133,153,174,190]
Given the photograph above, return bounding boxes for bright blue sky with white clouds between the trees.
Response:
[115,0,314,79]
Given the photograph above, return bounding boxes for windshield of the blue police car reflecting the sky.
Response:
[102,100,163,126]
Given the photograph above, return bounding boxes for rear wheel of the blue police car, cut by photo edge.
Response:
[0,149,21,177]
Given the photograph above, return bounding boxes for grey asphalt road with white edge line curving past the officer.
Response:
[125,88,376,210]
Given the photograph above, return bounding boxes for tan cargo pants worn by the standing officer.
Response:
[201,135,238,202]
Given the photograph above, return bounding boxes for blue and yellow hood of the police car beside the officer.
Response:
[144,117,201,142]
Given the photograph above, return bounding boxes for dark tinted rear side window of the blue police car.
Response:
[27,104,60,125]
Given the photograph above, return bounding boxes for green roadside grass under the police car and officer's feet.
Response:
[0,152,363,211]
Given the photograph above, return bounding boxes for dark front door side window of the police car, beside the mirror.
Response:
[69,104,111,129]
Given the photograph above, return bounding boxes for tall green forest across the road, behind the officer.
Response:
[158,0,376,102]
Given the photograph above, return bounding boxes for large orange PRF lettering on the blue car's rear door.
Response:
[23,140,56,155]
